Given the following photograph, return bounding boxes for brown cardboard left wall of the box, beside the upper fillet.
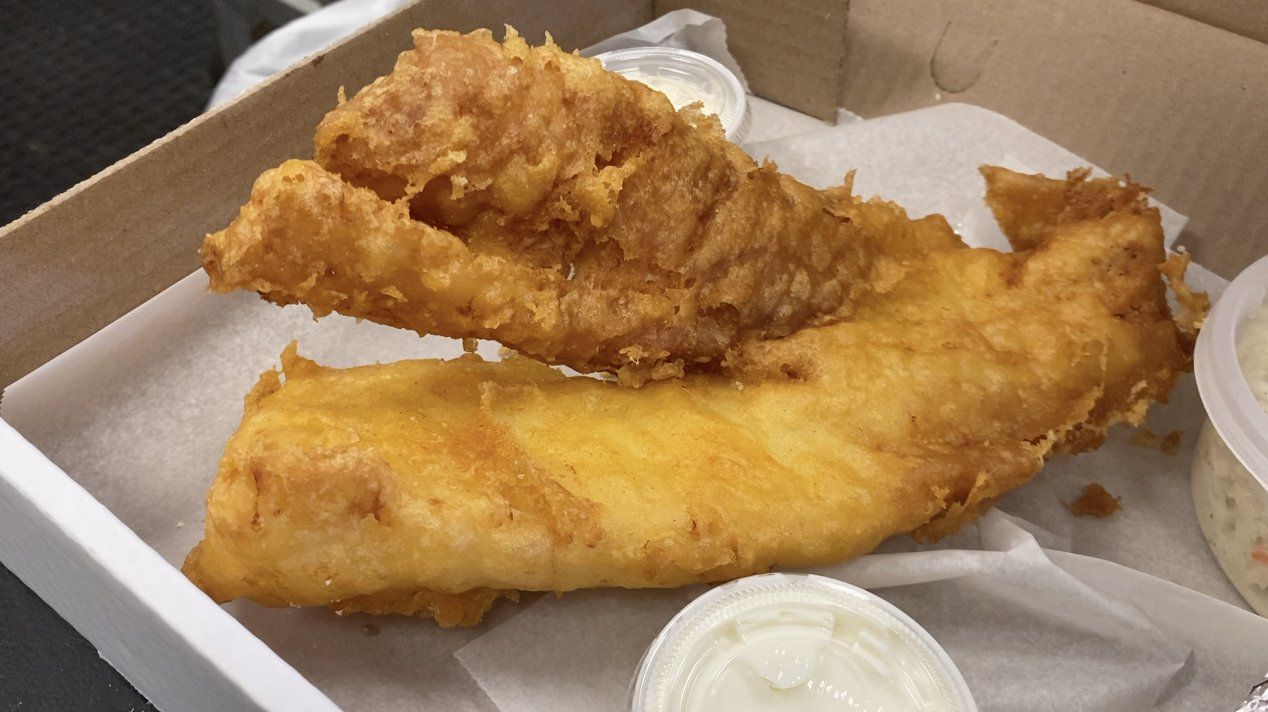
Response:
[0,0,653,388]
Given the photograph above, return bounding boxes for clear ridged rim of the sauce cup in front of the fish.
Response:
[630,573,978,712]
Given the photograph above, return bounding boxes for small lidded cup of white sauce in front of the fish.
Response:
[630,574,978,712]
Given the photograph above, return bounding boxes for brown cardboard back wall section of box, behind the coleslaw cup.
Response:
[842,0,1268,276]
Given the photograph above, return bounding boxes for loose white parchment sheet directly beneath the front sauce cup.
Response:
[458,509,1268,712]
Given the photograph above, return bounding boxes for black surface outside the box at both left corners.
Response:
[0,0,219,712]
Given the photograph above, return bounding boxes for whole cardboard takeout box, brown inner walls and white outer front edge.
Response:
[0,0,1268,709]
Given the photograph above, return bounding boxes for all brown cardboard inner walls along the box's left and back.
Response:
[0,0,1268,386]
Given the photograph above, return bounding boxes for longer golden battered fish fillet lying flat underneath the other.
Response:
[184,172,1191,625]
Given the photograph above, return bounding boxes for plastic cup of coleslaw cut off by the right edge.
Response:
[1192,257,1268,617]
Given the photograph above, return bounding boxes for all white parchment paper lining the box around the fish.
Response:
[0,15,1268,712]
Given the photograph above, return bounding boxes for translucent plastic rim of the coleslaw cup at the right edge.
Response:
[1193,252,1268,489]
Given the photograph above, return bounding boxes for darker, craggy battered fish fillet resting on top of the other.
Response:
[203,30,871,378]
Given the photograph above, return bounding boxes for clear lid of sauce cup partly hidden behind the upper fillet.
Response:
[595,47,748,143]
